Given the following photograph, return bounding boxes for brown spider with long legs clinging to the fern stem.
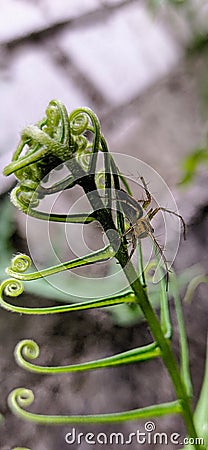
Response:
[116,177,186,289]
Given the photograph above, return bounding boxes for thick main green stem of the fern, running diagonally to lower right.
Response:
[64,154,203,450]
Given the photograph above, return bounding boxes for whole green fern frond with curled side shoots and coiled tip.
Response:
[0,101,208,449]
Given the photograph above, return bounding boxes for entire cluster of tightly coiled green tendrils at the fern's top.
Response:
[4,100,102,216]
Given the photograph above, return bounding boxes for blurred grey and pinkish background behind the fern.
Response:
[0,0,208,450]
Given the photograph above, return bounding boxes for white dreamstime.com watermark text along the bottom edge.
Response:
[65,421,204,445]
